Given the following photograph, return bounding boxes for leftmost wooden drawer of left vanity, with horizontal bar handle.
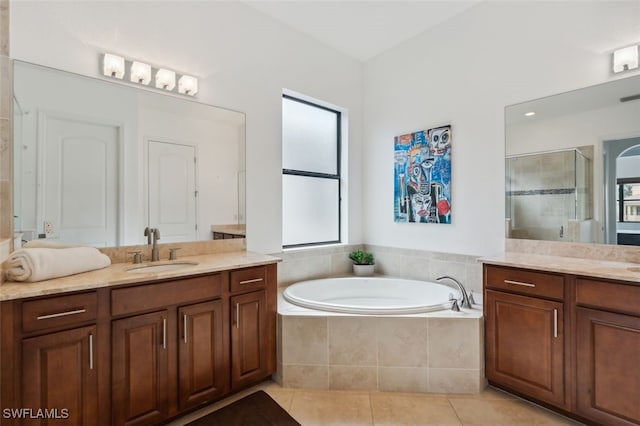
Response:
[22,292,98,333]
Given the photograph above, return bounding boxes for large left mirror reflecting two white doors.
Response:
[13,61,245,247]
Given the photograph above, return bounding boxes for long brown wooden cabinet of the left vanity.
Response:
[0,263,277,426]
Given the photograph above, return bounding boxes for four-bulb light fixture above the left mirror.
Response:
[102,53,198,96]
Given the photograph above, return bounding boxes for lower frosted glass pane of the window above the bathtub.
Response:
[282,174,340,246]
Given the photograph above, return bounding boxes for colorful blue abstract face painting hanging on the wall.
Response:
[393,126,451,223]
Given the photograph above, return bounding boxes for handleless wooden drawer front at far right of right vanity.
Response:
[576,278,640,316]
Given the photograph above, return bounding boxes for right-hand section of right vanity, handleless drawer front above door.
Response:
[576,279,640,425]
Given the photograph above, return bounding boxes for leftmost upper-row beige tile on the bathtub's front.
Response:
[282,316,329,365]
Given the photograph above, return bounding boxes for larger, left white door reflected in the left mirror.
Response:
[38,116,119,247]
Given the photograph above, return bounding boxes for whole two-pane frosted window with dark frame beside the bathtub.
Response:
[282,95,341,248]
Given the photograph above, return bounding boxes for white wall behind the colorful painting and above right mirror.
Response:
[363,1,640,255]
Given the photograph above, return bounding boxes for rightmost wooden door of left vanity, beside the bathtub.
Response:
[231,290,269,389]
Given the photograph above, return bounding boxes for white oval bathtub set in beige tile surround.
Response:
[283,277,460,315]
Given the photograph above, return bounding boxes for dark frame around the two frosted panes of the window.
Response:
[282,93,343,249]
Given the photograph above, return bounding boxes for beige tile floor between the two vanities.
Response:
[170,382,580,426]
